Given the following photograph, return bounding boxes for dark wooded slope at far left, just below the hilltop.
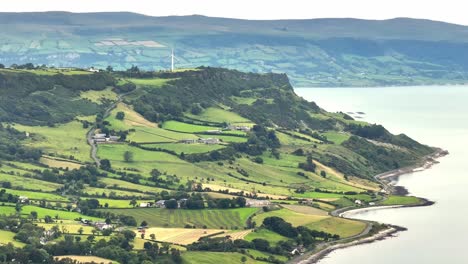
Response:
[0,72,115,125]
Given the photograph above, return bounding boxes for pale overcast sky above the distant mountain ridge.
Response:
[0,0,468,25]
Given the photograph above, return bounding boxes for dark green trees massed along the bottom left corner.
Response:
[0,223,182,264]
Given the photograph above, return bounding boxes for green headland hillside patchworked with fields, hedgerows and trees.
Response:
[0,67,433,264]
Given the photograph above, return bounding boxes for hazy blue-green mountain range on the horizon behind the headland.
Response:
[0,12,468,86]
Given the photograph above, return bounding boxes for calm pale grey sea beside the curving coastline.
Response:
[296,86,468,264]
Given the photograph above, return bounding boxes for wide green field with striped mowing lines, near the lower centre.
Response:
[101,208,257,229]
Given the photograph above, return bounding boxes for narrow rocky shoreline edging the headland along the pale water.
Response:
[288,148,449,264]
